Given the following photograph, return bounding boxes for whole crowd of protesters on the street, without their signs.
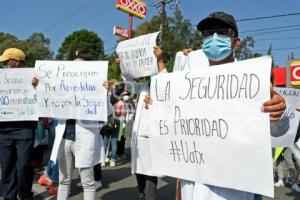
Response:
[0,12,300,200]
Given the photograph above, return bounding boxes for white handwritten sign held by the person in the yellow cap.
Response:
[0,68,38,121]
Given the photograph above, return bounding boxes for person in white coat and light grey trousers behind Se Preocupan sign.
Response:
[47,54,111,200]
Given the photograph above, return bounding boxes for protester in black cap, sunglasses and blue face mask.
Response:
[145,12,289,200]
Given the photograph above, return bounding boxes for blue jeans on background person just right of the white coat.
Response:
[103,129,118,160]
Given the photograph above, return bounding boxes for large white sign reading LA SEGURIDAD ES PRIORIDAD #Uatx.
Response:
[140,57,274,197]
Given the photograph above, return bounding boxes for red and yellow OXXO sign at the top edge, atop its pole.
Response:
[116,0,147,19]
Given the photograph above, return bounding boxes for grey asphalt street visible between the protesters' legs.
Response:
[0,149,300,200]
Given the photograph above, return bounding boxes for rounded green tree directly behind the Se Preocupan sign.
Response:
[56,29,104,60]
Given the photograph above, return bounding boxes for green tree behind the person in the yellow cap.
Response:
[0,33,53,67]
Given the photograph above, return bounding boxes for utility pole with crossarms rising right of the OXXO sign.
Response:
[154,0,179,47]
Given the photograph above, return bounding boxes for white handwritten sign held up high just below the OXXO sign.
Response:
[116,32,159,78]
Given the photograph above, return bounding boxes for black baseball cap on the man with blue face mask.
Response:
[197,12,239,37]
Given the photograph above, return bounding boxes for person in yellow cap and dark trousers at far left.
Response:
[0,48,37,200]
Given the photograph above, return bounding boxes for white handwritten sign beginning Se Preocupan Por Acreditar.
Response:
[35,61,108,121]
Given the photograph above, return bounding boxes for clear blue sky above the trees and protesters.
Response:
[0,0,300,66]
